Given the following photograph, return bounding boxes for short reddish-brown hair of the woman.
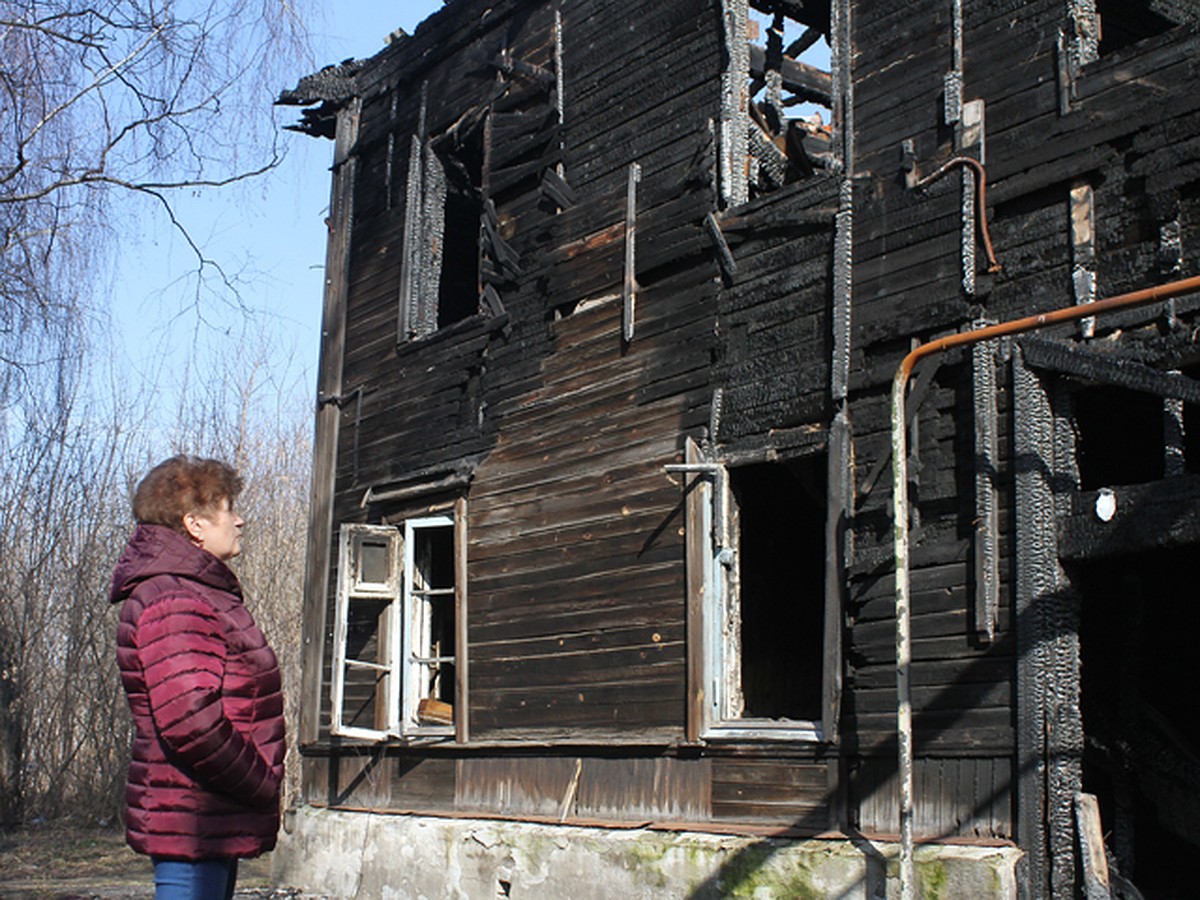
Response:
[133,454,242,534]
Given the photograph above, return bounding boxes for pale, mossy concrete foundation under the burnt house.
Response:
[274,806,1020,900]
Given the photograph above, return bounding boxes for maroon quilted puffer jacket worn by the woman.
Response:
[110,524,284,859]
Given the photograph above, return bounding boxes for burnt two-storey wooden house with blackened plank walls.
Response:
[282,0,1200,896]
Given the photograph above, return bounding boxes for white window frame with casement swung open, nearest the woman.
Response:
[330,511,466,743]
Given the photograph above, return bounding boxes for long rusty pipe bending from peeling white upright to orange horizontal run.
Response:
[892,273,1200,900]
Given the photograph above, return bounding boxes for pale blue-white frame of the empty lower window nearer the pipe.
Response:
[681,442,829,742]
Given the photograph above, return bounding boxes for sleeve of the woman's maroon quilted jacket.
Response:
[137,596,280,806]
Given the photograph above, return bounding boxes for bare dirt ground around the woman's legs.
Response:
[0,827,295,900]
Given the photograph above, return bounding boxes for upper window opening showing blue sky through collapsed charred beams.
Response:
[746,0,833,196]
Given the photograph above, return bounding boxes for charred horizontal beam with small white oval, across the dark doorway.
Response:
[1058,475,1200,560]
